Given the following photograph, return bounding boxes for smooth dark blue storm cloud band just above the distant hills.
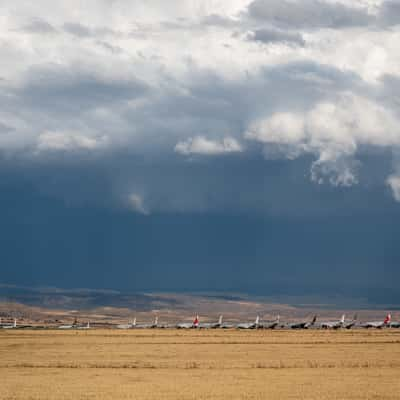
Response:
[0,155,400,302]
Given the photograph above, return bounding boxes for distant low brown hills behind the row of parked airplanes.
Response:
[0,285,396,323]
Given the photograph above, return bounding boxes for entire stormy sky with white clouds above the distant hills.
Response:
[0,0,400,303]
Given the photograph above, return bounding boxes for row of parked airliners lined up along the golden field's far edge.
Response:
[0,314,400,329]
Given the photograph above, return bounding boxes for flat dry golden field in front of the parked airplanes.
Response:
[0,330,400,400]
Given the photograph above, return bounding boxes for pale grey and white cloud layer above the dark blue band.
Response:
[0,0,400,214]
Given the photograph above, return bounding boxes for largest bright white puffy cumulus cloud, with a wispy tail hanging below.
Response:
[245,94,400,186]
